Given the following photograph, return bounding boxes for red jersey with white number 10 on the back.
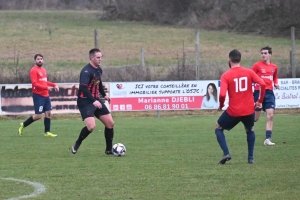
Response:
[219,66,265,116]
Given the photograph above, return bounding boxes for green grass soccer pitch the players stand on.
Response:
[0,113,300,200]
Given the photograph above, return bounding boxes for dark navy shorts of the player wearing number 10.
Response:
[218,110,254,131]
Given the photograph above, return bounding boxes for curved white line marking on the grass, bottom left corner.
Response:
[0,177,46,200]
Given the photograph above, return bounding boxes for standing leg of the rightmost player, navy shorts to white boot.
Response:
[263,90,275,146]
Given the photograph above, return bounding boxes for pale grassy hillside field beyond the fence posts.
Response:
[0,11,300,70]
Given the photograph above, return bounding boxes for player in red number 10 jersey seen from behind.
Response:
[215,49,265,164]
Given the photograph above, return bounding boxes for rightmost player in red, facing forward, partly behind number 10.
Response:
[252,46,279,146]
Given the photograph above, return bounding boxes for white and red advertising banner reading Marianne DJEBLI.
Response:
[110,81,218,111]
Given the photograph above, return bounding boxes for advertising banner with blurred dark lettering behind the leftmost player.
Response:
[0,83,110,115]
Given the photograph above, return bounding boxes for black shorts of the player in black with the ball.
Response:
[77,99,110,120]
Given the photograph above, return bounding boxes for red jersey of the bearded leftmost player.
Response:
[30,66,56,97]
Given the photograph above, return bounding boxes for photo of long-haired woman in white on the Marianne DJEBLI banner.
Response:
[201,83,219,109]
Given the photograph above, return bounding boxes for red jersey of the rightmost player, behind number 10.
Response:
[252,61,278,90]
